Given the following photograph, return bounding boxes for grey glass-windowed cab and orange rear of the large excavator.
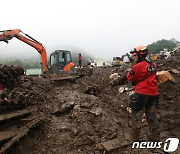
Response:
[49,50,75,74]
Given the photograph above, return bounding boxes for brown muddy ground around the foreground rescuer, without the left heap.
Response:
[1,53,180,154]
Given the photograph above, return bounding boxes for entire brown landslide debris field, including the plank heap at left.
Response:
[0,49,180,154]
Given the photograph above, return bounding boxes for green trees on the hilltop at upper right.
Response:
[147,38,180,53]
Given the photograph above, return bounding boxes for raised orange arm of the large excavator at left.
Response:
[0,29,48,73]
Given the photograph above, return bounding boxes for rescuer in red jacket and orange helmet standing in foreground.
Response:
[126,45,160,141]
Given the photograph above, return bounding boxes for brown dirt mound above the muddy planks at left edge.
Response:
[0,74,51,107]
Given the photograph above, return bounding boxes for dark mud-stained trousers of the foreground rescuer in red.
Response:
[131,94,160,141]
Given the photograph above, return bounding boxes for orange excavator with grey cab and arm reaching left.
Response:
[0,29,83,81]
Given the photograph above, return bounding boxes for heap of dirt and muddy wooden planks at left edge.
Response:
[0,70,52,153]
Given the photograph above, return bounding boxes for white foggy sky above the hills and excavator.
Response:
[0,0,180,60]
